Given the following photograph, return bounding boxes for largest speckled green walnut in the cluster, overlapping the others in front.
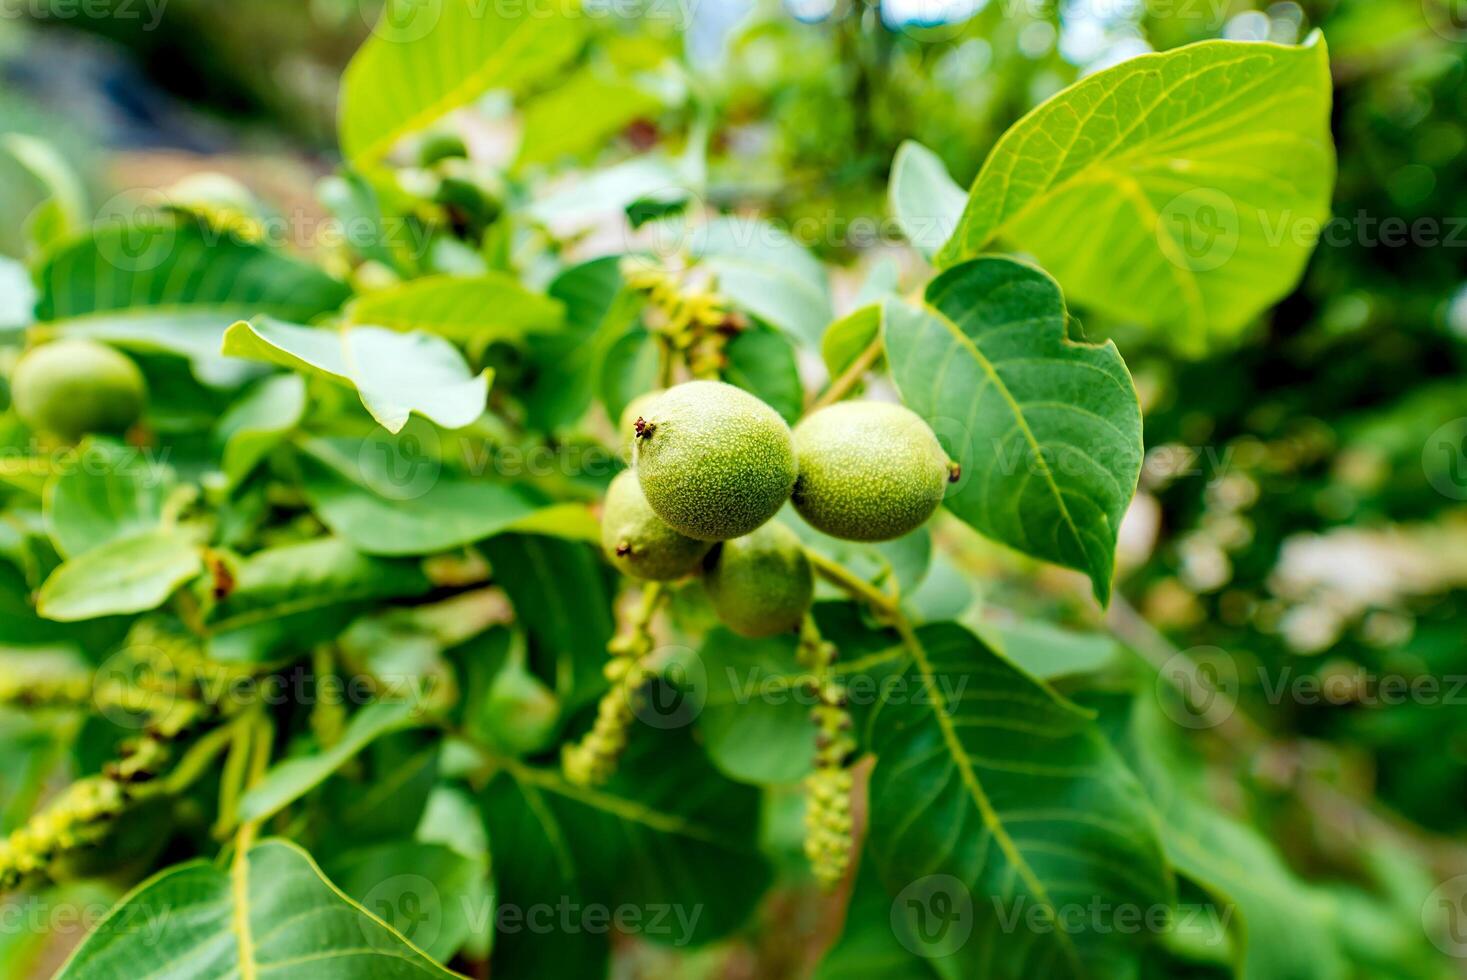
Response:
[632,381,795,541]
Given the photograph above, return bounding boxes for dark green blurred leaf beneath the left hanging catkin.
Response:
[481,725,769,977]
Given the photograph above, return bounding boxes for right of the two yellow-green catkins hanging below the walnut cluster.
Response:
[800,616,855,889]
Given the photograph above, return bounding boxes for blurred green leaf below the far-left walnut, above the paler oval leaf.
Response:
[43,440,173,557]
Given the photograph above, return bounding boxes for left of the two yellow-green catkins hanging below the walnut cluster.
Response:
[560,582,663,786]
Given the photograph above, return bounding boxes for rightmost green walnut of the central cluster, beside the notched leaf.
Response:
[792,402,956,541]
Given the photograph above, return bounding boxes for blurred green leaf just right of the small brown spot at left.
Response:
[208,538,430,663]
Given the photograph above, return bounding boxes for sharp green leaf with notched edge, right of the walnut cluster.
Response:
[883,257,1141,604]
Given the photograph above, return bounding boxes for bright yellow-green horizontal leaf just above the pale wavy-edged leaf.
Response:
[346,271,565,343]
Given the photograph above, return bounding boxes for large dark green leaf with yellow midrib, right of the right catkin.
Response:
[870,624,1175,977]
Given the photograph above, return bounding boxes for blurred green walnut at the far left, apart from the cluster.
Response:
[10,340,148,440]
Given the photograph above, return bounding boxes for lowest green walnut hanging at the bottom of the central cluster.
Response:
[703,522,816,637]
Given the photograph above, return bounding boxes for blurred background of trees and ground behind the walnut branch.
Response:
[0,0,1467,976]
